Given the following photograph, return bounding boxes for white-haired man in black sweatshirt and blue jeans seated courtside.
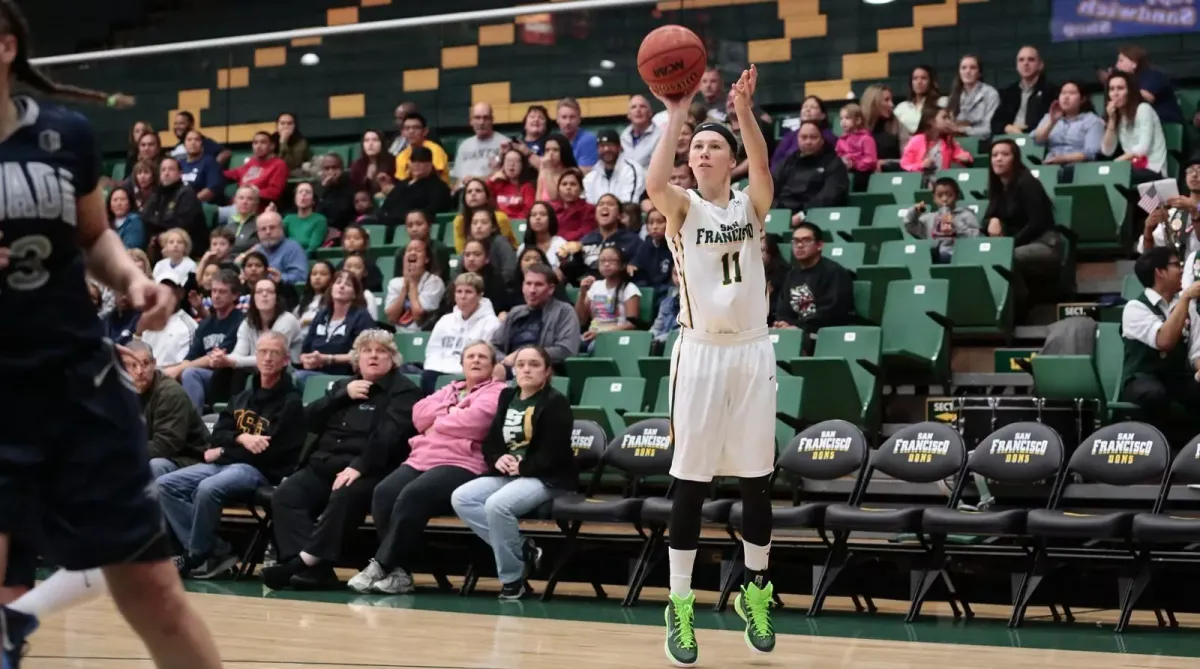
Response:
[157,332,305,579]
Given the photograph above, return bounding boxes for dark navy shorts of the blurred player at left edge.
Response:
[0,346,170,578]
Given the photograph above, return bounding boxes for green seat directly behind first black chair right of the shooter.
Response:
[788,327,883,427]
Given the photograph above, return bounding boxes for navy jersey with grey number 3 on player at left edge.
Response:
[0,97,104,374]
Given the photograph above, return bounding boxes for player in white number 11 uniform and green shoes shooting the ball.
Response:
[646,66,775,667]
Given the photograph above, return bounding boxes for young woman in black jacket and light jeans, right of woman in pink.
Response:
[450,346,580,599]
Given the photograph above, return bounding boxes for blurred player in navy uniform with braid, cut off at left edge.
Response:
[0,0,221,669]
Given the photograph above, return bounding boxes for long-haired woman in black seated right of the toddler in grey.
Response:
[984,139,1062,309]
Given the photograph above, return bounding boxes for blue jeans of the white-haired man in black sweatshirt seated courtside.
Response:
[158,463,268,556]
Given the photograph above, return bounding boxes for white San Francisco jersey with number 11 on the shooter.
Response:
[667,191,768,333]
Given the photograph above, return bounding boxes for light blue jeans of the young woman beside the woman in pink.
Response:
[450,476,558,584]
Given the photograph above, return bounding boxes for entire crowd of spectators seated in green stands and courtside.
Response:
[84,47,1200,597]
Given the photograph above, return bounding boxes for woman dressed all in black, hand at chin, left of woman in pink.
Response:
[263,330,421,590]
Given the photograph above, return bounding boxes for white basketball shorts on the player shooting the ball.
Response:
[668,327,776,482]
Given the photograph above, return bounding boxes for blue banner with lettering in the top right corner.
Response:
[1050,0,1198,42]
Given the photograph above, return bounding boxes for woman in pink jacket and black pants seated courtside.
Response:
[349,342,504,595]
